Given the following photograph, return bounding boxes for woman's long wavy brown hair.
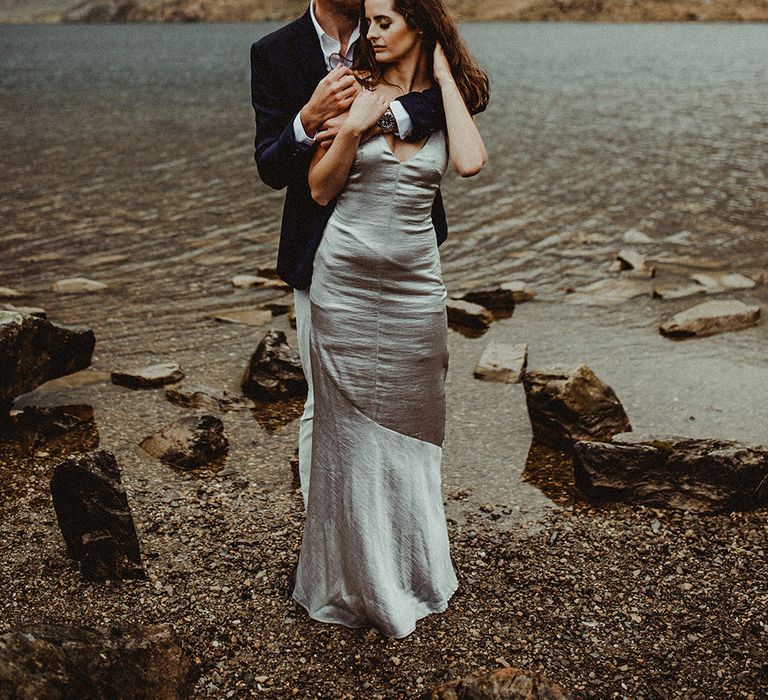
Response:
[352,0,491,114]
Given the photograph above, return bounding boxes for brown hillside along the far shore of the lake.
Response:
[0,0,768,22]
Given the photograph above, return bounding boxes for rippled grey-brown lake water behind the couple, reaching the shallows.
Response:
[0,23,768,516]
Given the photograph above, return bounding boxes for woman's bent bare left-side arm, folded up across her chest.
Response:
[309,90,389,206]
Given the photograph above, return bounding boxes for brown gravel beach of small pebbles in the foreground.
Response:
[0,418,768,699]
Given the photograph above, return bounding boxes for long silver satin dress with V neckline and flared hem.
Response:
[293,131,458,638]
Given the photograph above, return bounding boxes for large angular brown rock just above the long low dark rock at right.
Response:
[523,364,632,450]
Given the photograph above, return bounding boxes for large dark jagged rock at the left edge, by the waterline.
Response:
[0,311,96,405]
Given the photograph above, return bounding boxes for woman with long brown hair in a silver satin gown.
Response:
[293,0,489,638]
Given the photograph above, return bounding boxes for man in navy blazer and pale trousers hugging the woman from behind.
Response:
[251,0,447,508]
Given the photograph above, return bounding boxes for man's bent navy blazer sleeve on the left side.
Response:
[251,42,314,190]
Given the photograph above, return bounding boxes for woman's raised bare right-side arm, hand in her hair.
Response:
[434,43,488,177]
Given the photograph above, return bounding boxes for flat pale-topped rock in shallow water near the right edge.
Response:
[659,299,760,338]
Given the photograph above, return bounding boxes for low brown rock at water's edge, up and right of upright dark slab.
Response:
[139,414,229,469]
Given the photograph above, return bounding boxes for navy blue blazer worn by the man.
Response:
[251,10,448,289]
